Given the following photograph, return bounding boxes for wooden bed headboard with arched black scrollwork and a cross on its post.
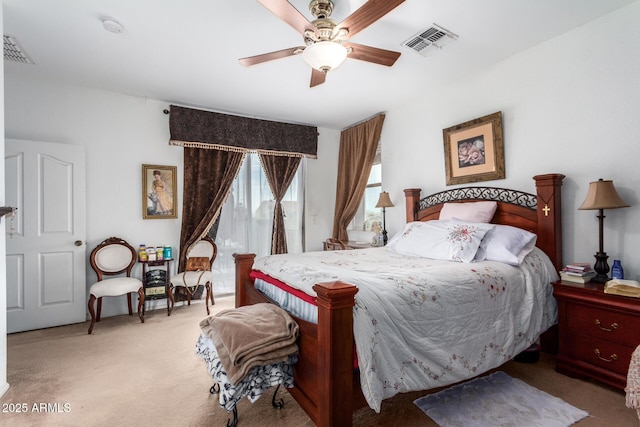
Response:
[404,174,564,270]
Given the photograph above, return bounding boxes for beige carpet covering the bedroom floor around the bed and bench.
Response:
[0,297,640,427]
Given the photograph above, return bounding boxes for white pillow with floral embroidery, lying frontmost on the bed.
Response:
[387,221,493,262]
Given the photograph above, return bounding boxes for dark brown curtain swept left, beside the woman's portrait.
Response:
[178,147,245,271]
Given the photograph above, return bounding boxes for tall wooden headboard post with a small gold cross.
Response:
[533,174,564,271]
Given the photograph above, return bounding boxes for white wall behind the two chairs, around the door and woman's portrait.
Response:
[5,78,182,317]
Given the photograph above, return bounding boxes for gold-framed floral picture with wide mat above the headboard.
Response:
[442,111,505,185]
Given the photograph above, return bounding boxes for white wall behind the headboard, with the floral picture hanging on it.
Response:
[382,2,640,279]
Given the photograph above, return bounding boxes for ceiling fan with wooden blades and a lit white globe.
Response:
[240,0,404,87]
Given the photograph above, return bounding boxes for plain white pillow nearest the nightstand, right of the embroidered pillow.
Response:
[475,225,538,265]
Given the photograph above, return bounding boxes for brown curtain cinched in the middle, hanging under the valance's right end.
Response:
[260,154,300,255]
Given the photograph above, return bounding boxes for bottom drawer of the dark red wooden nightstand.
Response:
[561,335,635,375]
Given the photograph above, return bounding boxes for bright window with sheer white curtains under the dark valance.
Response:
[213,153,306,293]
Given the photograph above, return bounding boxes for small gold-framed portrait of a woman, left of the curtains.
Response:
[142,165,178,219]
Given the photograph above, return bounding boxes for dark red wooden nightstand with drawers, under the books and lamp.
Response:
[552,281,640,390]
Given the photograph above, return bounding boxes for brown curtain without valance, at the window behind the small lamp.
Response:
[332,114,385,241]
